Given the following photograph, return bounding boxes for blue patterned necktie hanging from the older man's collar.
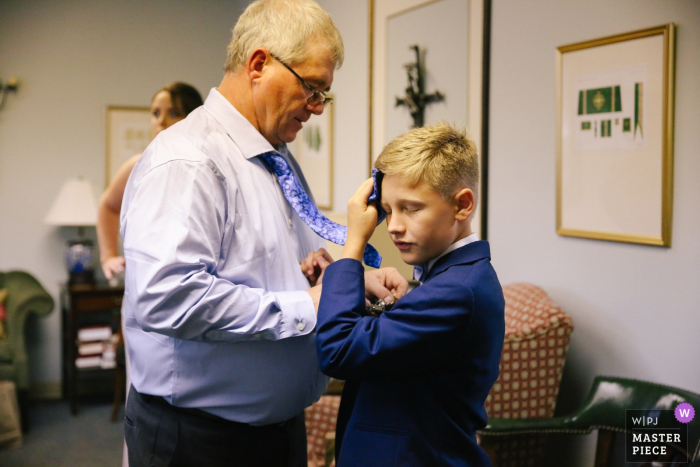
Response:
[260,152,382,268]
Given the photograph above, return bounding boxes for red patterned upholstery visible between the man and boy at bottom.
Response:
[305,396,340,467]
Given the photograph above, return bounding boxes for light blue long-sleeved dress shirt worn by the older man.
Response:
[121,89,328,425]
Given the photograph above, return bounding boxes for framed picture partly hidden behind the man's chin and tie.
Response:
[290,94,336,211]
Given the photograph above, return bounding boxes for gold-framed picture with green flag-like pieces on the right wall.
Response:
[556,24,675,247]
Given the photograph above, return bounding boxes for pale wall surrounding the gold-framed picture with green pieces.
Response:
[489,0,700,465]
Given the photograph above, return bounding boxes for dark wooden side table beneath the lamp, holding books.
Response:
[61,284,124,415]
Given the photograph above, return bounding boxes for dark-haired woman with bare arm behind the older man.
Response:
[97,82,203,281]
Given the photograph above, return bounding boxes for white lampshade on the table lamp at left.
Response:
[44,177,97,227]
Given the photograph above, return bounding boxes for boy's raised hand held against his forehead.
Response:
[343,178,377,261]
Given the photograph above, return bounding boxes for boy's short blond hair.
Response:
[374,122,479,203]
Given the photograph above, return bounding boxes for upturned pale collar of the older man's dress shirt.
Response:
[204,88,286,159]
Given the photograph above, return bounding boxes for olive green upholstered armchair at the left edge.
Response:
[0,271,54,427]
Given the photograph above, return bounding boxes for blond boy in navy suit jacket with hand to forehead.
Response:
[316,123,505,467]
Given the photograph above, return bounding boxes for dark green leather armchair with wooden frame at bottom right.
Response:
[482,376,700,467]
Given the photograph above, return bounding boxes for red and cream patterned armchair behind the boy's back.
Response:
[480,283,574,467]
